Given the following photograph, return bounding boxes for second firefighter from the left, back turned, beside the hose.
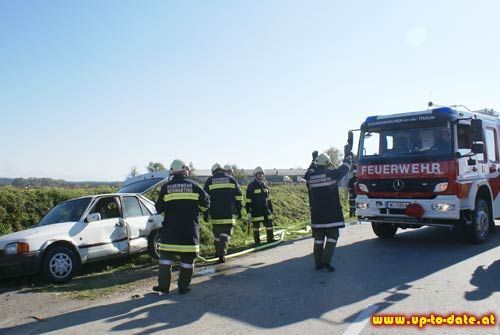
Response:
[203,163,243,263]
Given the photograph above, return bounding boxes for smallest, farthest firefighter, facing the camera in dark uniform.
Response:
[245,166,274,244]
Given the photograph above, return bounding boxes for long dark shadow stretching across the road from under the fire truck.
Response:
[4,224,500,334]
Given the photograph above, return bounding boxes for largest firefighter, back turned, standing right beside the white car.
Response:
[153,159,210,294]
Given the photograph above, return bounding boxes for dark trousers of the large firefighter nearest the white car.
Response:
[158,251,196,291]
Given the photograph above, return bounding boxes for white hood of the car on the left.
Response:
[0,222,76,250]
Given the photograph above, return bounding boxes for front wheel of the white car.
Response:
[42,246,78,283]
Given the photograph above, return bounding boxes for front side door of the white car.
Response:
[79,196,128,260]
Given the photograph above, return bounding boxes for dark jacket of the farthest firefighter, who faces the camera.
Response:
[245,178,273,222]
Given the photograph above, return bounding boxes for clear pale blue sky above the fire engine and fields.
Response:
[0,0,500,180]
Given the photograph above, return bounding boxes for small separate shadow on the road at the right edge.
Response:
[465,260,500,301]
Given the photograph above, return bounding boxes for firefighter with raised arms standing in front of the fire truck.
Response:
[305,154,351,272]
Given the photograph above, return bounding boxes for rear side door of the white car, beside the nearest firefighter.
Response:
[121,195,153,253]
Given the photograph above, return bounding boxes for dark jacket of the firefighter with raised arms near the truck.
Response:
[305,159,350,229]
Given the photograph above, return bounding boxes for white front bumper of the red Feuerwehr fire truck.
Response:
[356,195,460,224]
